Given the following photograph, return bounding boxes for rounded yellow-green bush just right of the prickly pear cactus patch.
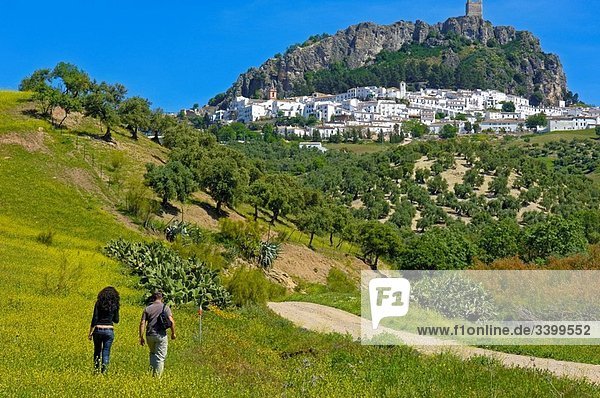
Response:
[226,267,285,306]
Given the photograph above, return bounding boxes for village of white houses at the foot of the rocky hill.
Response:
[203,82,600,139]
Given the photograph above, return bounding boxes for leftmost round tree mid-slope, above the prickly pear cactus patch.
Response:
[144,161,197,207]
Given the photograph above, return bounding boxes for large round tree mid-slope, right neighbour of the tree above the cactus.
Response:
[199,156,248,213]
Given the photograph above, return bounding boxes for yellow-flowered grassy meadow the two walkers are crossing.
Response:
[0,93,595,397]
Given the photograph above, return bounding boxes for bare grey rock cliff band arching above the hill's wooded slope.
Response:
[217,17,567,104]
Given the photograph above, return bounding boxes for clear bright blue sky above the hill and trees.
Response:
[0,0,600,111]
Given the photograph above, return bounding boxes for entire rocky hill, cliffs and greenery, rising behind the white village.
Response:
[216,17,567,105]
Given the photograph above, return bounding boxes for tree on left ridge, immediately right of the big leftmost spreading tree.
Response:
[84,82,127,141]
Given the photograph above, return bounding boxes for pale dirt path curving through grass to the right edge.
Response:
[269,302,600,384]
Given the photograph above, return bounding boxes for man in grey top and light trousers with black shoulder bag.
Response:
[140,292,176,376]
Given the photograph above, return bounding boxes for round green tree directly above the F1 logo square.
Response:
[358,221,402,269]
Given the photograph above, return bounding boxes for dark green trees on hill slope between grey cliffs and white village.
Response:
[295,35,560,104]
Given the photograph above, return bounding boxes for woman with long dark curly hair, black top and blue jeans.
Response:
[88,286,120,373]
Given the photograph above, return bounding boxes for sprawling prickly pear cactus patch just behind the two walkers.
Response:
[104,239,231,308]
